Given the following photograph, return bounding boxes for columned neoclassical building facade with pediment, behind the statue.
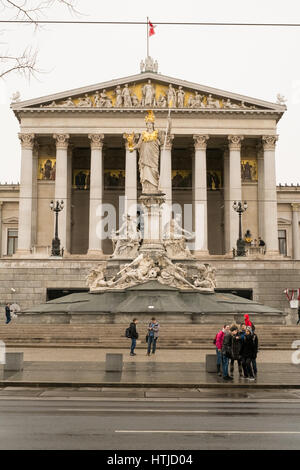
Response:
[8,61,300,259]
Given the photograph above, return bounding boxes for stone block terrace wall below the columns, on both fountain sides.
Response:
[0,258,300,311]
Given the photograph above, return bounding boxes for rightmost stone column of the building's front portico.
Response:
[262,135,279,256]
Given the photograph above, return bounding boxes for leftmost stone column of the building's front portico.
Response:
[16,133,34,257]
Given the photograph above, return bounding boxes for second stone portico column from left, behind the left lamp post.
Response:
[53,134,71,253]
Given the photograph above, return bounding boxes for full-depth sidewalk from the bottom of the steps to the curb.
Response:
[0,348,300,389]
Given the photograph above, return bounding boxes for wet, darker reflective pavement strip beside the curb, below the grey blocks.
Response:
[0,359,300,389]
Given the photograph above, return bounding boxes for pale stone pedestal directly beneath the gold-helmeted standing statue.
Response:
[139,193,165,252]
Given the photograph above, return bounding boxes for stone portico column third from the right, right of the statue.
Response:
[193,135,209,256]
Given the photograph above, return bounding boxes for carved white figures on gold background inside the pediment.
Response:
[40,79,260,110]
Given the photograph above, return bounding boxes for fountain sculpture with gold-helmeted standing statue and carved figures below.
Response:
[87,111,216,292]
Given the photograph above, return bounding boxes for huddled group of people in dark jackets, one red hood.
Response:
[214,315,258,381]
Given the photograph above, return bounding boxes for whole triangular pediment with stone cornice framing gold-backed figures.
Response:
[12,72,286,115]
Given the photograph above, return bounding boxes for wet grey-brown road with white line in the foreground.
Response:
[0,390,300,450]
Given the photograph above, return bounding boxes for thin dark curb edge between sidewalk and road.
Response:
[0,380,300,390]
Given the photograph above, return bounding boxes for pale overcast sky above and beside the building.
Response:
[0,0,300,184]
